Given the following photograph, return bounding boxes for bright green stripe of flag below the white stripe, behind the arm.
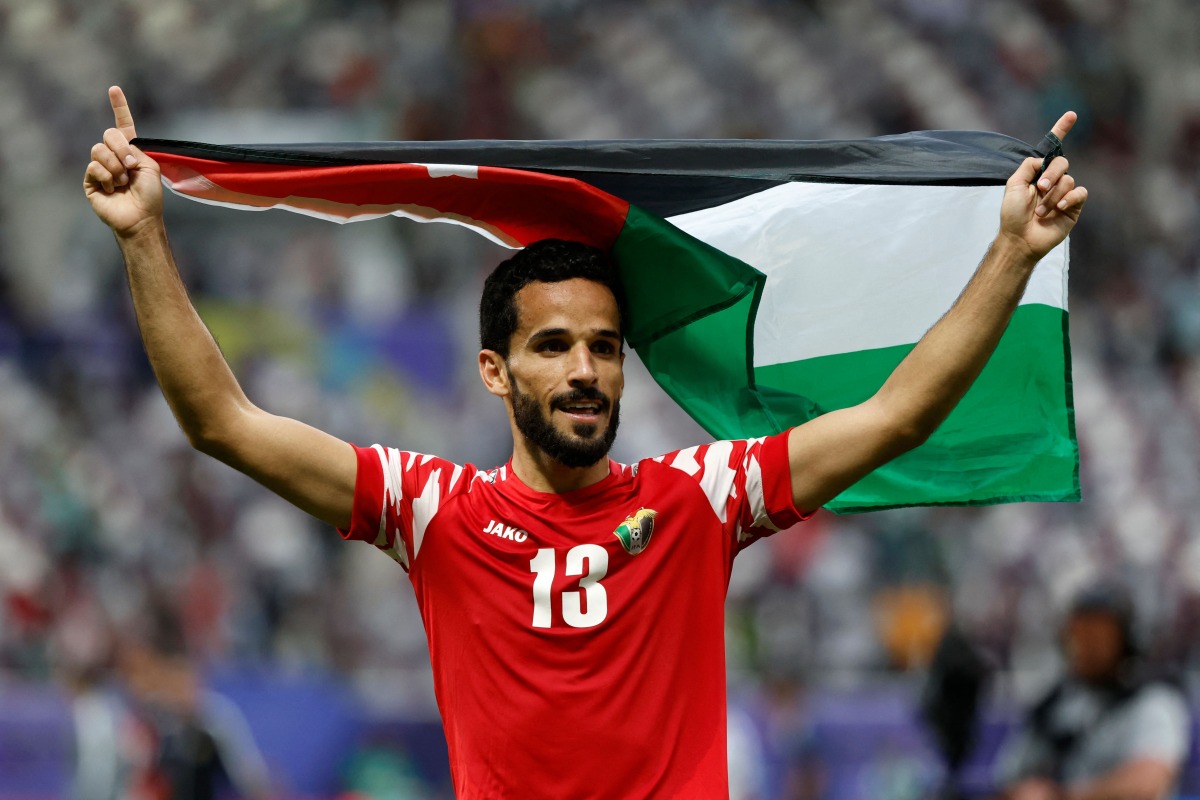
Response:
[755,299,1080,512]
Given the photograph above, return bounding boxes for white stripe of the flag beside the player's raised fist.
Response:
[670,184,1067,366]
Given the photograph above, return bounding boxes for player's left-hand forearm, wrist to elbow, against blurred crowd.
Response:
[118,218,248,450]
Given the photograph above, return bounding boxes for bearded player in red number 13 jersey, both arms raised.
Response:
[84,86,1087,798]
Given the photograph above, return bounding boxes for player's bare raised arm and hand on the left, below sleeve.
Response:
[83,86,358,528]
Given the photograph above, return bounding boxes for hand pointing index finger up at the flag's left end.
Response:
[83,86,162,237]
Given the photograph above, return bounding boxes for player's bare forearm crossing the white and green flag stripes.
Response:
[875,235,1036,440]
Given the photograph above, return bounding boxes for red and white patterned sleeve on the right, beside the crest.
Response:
[654,432,812,547]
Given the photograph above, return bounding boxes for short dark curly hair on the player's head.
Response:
[479,239,625,359]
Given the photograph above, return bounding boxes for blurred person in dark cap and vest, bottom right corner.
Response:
[1001,583,1189,800]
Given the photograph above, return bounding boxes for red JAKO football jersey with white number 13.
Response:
[342,434,802,800]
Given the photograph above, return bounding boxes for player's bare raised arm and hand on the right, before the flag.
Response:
[788,112,1087,511]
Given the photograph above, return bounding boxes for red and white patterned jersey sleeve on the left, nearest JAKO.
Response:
[338,445,474,570]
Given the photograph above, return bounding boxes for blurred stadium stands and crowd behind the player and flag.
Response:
[0,0,1200,800]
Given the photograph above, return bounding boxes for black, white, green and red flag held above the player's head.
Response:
[137,132,1079,512]
